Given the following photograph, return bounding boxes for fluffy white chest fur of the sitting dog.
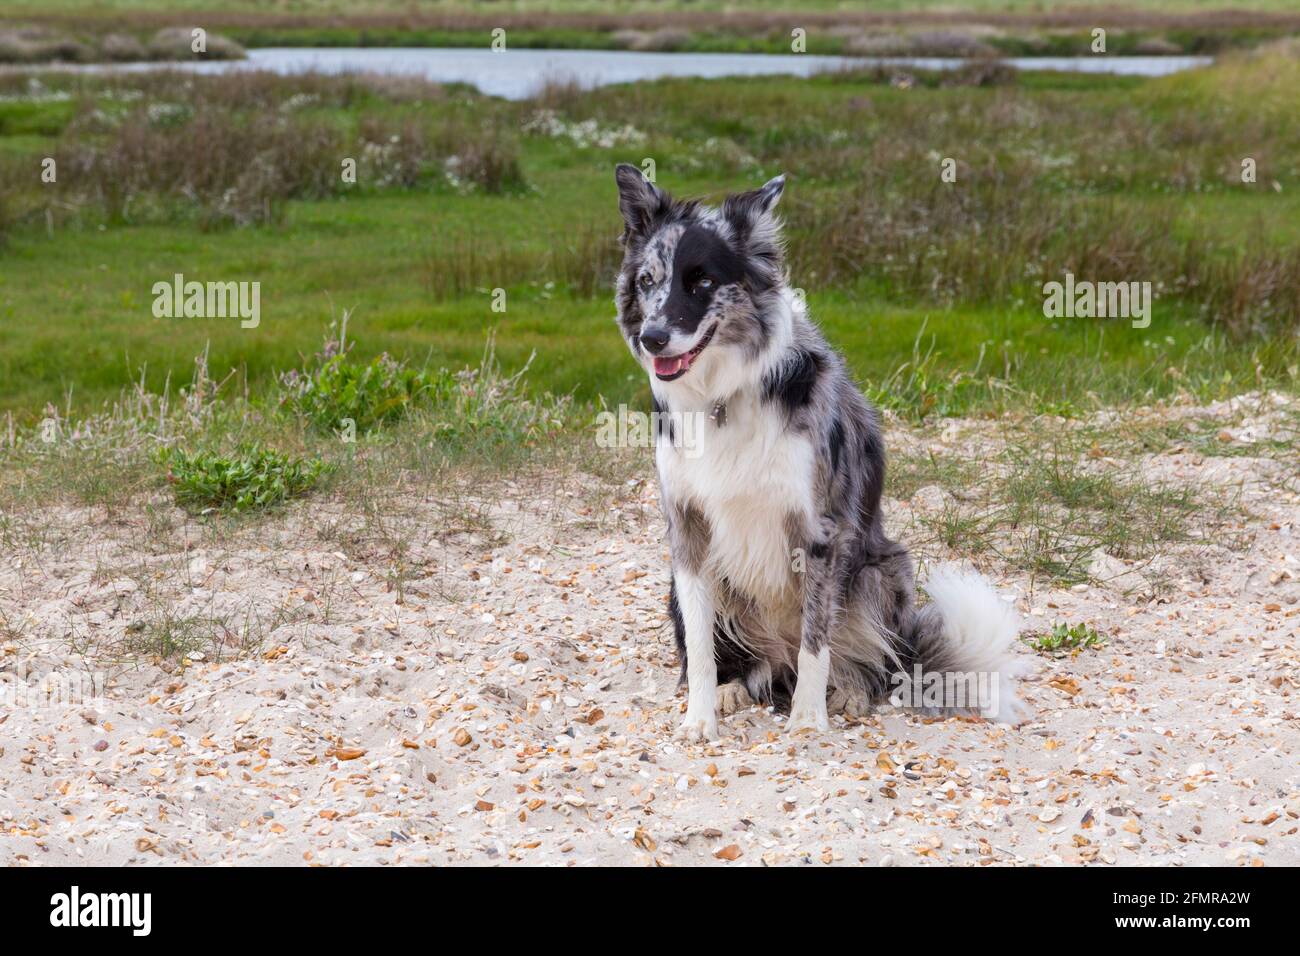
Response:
[657,397,813,606]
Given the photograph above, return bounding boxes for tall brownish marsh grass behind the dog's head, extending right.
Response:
[428,45,1300,338]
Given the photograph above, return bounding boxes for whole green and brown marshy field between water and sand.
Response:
[0,49,1300,423]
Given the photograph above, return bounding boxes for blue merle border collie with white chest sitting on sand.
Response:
[616,164,1023,740]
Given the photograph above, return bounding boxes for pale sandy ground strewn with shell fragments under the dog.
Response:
[0,395,1300,866]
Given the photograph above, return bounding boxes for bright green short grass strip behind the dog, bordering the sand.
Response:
[0,214,1269,415]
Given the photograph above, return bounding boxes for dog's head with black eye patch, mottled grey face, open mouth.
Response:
[615,164,785,382]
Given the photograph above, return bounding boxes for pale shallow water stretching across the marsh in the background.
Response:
[22,47,1212,99]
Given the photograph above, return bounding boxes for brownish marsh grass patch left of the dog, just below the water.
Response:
[0,73,525,235]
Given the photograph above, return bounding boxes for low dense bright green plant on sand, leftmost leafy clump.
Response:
[161,446,332,514]
